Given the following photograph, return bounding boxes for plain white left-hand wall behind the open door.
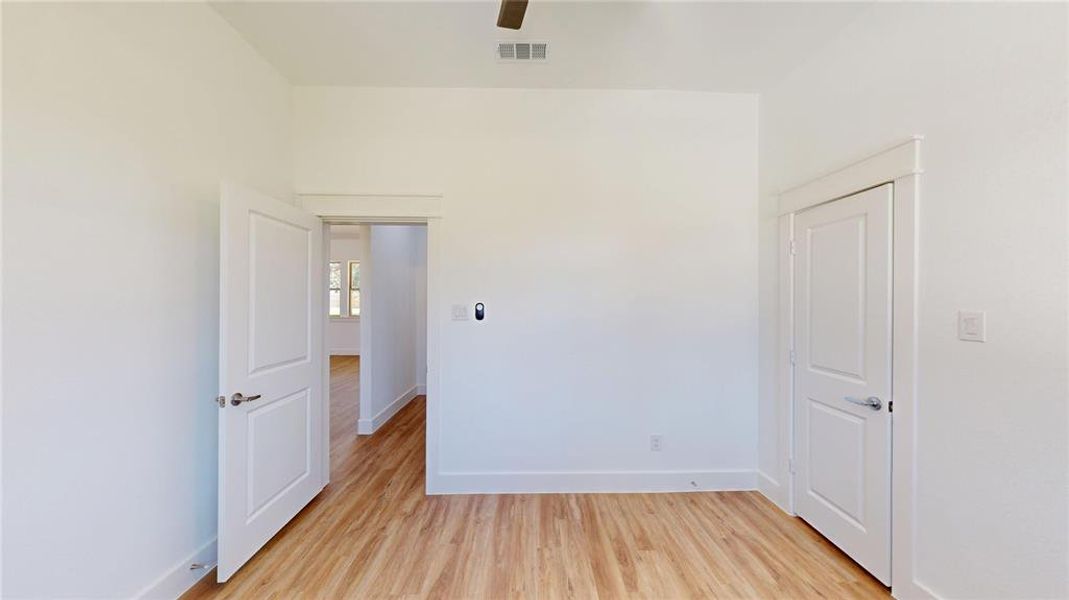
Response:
[2,3,291,598]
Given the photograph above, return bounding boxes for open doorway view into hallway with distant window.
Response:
[325,221,428,464]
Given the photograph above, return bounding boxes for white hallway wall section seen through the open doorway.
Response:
[357,225,427,433]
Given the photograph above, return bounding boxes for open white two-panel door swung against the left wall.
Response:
[218,184,326,582]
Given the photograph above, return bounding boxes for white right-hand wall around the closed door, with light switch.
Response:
[756,3,1069,598]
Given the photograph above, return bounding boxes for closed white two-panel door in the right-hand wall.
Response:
[794,184,893,585]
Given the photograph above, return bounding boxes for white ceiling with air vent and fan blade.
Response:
[212,0,867,92]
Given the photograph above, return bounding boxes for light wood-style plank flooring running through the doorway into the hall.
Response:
[185,357,889,599]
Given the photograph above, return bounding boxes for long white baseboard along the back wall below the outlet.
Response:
[428,471,757,494]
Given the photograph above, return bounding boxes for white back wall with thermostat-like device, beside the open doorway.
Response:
[294,88,757,492]
